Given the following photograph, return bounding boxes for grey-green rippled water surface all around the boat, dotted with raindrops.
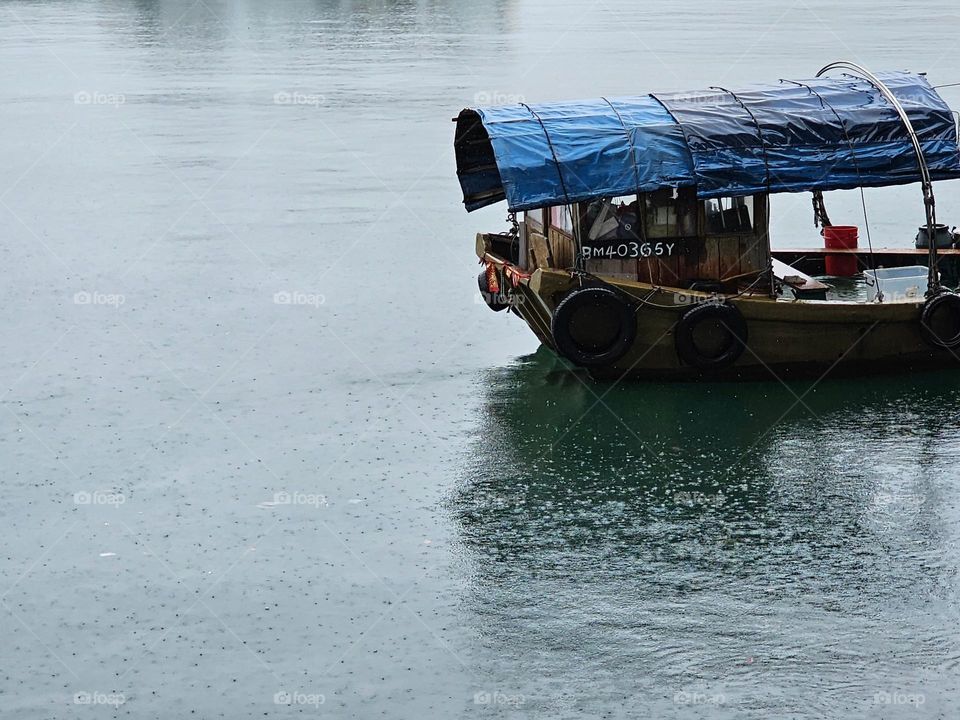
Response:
[0,0,960,720]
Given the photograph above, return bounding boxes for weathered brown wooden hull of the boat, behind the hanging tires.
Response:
[498,262,960,380]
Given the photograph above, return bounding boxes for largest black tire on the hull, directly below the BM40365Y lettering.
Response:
[550,287,637,367]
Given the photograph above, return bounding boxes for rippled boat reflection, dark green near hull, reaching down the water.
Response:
[452,350,960,717]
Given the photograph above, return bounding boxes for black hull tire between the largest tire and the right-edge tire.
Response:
[674,303,747,372]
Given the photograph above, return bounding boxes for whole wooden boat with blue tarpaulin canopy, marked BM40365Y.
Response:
[454,62,960,379]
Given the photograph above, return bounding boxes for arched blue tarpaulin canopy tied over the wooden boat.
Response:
[454,72,960,211]
